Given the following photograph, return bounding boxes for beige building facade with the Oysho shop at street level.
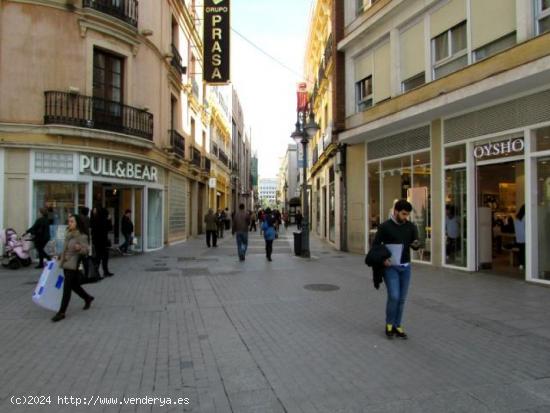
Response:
[338,0,550,283]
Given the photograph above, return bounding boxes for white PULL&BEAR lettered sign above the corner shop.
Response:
[80,155,158,182]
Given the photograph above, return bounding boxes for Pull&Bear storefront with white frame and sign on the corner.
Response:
[29,150,164,251]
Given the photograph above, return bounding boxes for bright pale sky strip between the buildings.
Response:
[231,0,313,178]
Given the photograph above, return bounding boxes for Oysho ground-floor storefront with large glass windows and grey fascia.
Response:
[365,91,550,284]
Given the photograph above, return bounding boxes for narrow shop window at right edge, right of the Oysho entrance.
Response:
[533,157,550,280]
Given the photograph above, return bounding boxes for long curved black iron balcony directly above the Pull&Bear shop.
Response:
[44,91,153,141]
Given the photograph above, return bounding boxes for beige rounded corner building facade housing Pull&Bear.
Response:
[0,0,216,251]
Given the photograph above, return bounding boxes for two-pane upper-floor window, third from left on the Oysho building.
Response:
[432,21,468,79]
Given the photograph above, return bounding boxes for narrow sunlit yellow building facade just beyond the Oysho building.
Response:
[305,0,345,249]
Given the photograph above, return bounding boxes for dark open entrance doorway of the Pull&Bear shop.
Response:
[93,182,143,251]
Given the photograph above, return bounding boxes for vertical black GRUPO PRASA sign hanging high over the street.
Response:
[203,0,231,84]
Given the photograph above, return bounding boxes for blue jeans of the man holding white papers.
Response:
[384,265,411,327]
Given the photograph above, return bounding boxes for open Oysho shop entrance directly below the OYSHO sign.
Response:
[476,160,525,277]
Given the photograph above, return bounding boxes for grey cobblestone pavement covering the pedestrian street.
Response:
[0,227,550,413]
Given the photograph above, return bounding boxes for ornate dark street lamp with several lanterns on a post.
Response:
[290,102,321,254]
